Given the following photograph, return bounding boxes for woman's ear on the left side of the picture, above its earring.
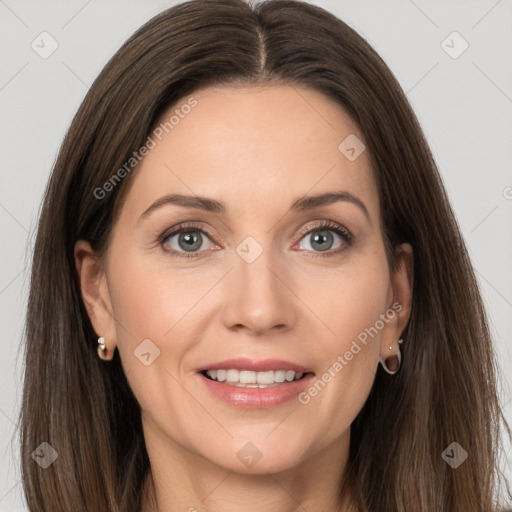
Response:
[74,240,117,352]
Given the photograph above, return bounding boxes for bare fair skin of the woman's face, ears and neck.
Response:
[75,85,412,512]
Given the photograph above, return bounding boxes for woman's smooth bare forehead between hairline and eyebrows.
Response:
[118,85,378,224]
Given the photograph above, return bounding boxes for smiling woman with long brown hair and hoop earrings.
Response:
[21,0,506,512]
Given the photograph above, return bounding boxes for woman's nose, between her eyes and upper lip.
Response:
[223,240,300,335]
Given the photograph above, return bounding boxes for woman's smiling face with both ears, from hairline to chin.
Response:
[75,86,410,473]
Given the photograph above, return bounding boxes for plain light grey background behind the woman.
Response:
[0,0,512,512]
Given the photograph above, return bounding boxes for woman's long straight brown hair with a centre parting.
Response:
[20,0,508,512]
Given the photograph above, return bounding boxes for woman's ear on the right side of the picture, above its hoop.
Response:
[380,243,414,359]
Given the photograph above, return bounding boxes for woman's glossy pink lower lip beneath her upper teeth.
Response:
[197,373,314,409]
